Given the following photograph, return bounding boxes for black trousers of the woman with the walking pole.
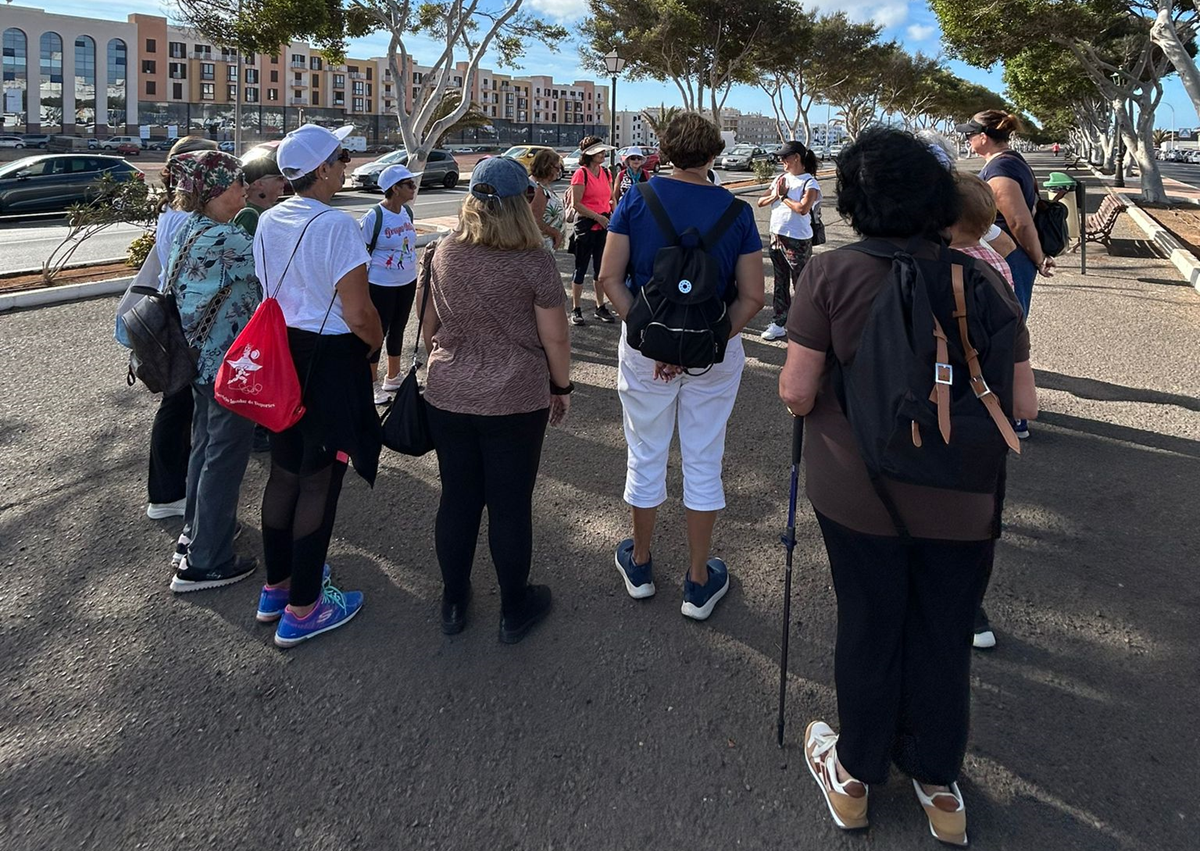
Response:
[817,514,995,785]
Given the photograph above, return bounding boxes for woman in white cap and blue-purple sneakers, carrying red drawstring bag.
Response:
[254,125,383,647]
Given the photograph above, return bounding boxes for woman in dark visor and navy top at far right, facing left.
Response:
[955,109,1055,439]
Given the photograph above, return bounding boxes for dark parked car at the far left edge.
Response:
[0,154,145,216]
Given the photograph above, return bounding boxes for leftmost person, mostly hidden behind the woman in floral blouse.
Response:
[146,136,217,520]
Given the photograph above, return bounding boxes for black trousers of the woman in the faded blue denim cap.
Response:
[427,404,550,615]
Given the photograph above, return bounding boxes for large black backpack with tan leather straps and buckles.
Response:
[830,239,1021,538]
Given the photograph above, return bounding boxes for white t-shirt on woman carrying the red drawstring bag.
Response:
[254,196,371,335]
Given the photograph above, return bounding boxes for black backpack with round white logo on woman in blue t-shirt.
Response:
[625,182,746,370]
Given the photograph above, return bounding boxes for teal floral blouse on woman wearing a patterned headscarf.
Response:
[166,212,263,384]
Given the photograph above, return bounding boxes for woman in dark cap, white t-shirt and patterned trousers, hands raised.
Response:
[758,139,821,340]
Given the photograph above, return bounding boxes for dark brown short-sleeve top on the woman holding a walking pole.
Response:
[787,240,1030,540]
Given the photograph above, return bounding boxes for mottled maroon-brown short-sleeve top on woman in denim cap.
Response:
[422,236,563,416]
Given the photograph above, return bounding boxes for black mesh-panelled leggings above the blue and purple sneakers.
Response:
[263,429,346,606]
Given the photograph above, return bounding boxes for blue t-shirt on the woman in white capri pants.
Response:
[608,178,762,298]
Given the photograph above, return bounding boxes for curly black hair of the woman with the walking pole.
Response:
[838,127,960,238]
